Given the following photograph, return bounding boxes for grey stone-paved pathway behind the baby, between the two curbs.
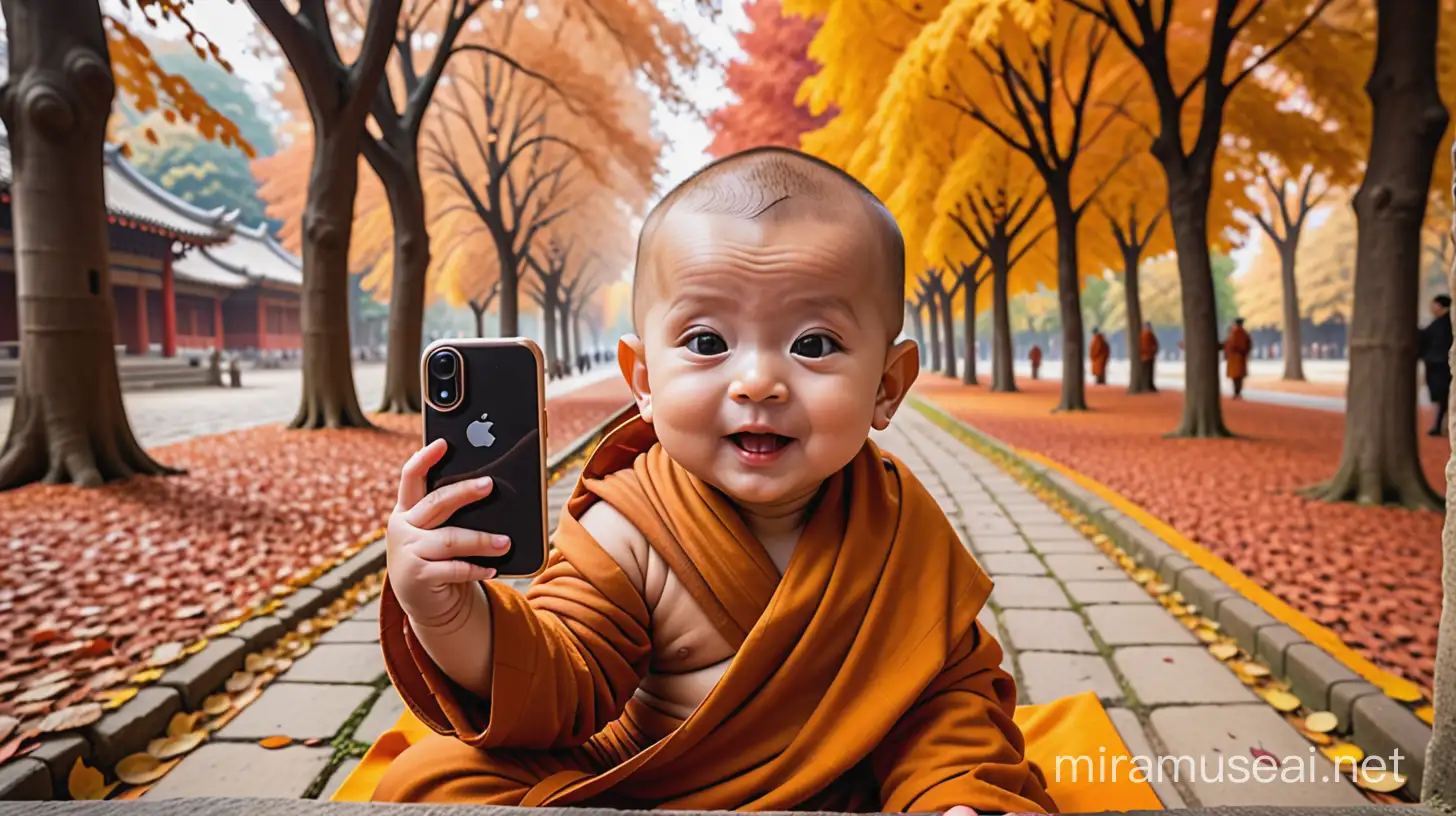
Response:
[133,411,1366,807]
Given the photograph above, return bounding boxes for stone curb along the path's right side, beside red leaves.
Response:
[914,399,1431,791]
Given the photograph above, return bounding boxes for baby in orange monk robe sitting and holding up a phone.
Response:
[376,149,1056,812]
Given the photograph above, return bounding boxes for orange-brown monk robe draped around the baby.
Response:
[374,418,1056,812]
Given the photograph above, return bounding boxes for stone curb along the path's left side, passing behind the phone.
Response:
[0,405,632,800]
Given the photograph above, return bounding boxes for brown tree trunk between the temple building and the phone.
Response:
[290,128,369,428]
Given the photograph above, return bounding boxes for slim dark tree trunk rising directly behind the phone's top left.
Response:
[364,140,430,414]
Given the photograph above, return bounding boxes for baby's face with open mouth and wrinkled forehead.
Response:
[636,208,914,509]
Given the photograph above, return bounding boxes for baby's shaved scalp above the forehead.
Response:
[632,147,906,340]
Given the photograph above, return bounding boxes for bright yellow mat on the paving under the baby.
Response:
[331,692,1163,813]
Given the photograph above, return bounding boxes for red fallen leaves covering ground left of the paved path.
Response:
[0,377,630,716]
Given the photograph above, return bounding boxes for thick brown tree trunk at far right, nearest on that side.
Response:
[1307,0,1449,509]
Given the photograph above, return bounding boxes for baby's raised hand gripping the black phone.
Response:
[386,440,511,628]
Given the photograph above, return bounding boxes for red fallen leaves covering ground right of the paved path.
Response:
[916,374,1450,689]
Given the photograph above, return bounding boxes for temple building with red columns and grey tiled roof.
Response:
[0,137,303,357]
